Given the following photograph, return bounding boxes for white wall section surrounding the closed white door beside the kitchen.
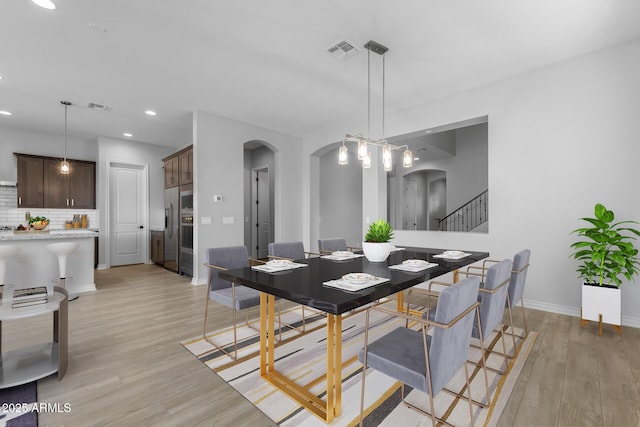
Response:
[96,137,175,267]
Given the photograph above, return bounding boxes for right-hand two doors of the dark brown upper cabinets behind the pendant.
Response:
[44,159,96,209]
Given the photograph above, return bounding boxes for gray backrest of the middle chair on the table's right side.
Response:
[473,259,512,339]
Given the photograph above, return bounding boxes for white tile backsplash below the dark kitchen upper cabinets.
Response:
[0,186,98,229]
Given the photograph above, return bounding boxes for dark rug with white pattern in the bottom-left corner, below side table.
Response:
[0,381,38,427]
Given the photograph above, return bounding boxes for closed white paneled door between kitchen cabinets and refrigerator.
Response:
[109,165,146,266]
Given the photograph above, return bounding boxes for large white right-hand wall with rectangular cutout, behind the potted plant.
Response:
[303,41,640,326]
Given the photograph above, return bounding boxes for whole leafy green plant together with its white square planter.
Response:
[571,203,640,334]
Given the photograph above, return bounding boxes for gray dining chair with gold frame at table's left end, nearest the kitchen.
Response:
[202,246,282,360]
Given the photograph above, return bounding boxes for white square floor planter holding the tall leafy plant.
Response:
[582,284,622,326]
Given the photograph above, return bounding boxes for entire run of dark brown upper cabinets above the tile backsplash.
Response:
[16,154,96,209]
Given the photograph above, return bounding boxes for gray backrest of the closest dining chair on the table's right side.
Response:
[430,276,480,395]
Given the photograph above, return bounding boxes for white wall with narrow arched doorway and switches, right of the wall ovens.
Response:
[193,111,303,283]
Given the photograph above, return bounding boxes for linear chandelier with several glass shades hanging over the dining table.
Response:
[338,40,413,172]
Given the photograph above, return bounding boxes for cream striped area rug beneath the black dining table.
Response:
[181,301,537,427]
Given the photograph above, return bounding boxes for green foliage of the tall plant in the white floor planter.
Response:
[571,203,640,287]
